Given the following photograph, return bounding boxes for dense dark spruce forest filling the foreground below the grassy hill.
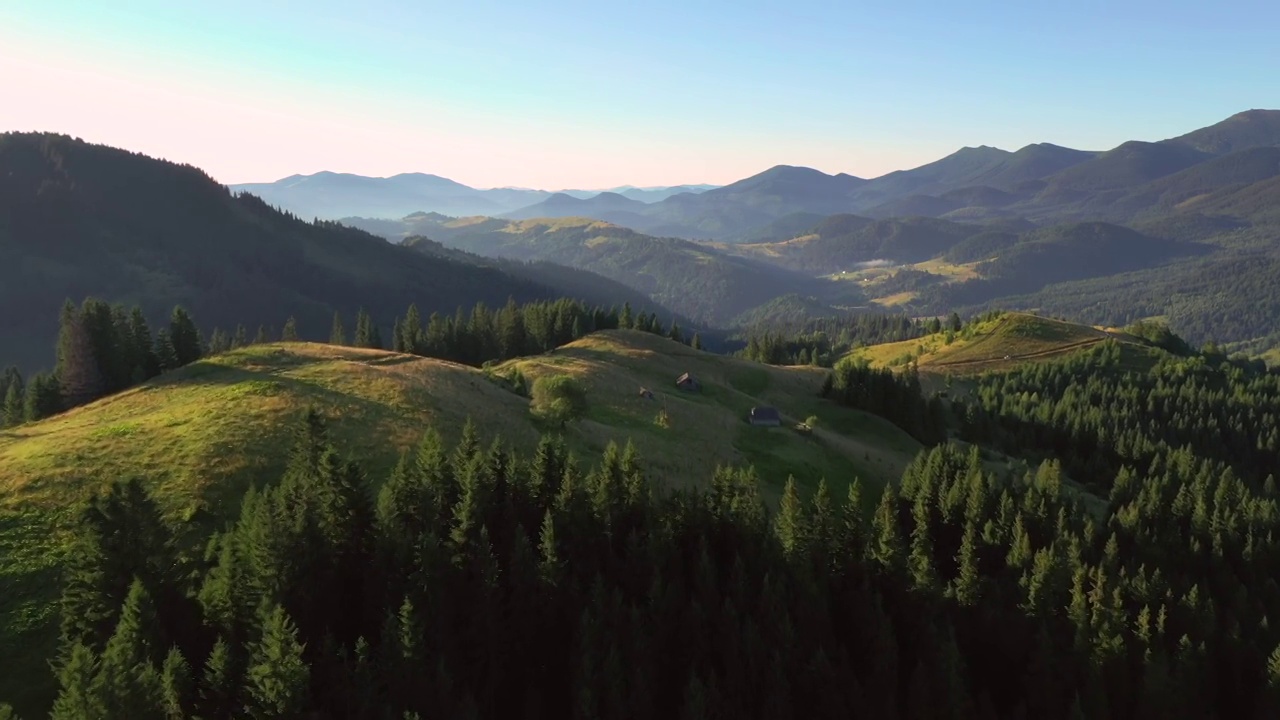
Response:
[17,414,1280,720]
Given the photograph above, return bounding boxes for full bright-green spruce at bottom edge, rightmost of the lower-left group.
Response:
[246,605,311,720]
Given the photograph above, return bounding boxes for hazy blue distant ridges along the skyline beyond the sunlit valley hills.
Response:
[290,110,1280,242]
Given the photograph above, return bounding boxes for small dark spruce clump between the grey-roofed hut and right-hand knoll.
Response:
[822,359,947,445]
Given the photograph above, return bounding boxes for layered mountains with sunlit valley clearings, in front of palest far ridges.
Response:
[343,110,1280,350]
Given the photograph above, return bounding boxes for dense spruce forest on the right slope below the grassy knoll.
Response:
[952,336,1280,493]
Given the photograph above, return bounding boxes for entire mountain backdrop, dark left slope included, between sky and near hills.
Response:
[0,110,1280,368]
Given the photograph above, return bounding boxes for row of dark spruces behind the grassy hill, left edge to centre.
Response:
[0,297,701,427]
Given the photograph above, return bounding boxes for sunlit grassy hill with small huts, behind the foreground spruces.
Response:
[0,331,919,706]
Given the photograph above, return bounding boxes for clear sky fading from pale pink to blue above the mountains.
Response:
[0,0,1280,190]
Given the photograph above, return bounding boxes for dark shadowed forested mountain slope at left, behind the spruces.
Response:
[0,133,570,369]
